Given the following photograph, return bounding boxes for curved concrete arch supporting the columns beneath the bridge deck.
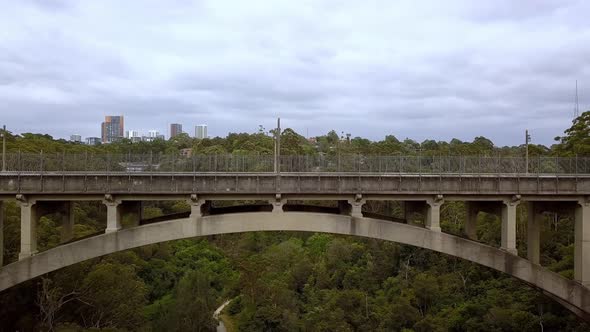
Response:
[0,212,590,319]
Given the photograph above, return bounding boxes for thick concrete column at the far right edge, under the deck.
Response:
[574,200,590,287]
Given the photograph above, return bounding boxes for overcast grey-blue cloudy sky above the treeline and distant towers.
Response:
[0,0,590,145]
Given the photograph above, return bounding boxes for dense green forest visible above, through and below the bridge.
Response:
[0,111,590,331]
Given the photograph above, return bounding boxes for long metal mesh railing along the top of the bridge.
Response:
[0,153,590,175]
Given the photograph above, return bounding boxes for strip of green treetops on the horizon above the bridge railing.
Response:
[6,111,590,156]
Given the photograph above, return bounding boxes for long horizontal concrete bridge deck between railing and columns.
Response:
[0,172,590,195]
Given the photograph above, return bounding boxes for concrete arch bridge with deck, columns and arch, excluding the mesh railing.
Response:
[0,166,590,319]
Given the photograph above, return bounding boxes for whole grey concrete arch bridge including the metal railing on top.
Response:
[0,154,590,319]
